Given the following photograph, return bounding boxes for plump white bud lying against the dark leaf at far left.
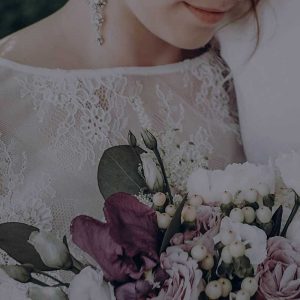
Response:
[28,231,72,269]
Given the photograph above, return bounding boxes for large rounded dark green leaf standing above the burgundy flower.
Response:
[98,145,147,199]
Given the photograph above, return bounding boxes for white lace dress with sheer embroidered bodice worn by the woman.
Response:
[0,50,243,296]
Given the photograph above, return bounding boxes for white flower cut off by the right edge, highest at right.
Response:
[275,152,300,195]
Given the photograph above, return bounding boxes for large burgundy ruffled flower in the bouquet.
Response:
[71,193,159,283]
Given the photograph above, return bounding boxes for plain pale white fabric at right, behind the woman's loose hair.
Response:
[218,0,300,163]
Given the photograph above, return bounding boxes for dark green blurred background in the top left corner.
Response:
[0,0,67,39]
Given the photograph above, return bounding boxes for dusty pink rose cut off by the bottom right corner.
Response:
[257,237,300,300]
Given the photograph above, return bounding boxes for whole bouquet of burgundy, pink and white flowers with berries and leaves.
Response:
[0,131,300,300]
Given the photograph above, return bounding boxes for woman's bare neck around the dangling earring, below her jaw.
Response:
[60,0,183,68]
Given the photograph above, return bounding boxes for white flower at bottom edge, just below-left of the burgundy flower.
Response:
[68,267,115,300]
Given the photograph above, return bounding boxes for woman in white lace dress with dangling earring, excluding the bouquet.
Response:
[0,0,255,296]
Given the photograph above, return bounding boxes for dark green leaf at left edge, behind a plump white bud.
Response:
[0,222,52,271]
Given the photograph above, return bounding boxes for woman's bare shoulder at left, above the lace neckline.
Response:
[0,6,72,67]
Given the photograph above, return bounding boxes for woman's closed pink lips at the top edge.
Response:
[185,2,227,25]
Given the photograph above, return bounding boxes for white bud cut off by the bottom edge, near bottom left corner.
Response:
[28,287,68,300]
